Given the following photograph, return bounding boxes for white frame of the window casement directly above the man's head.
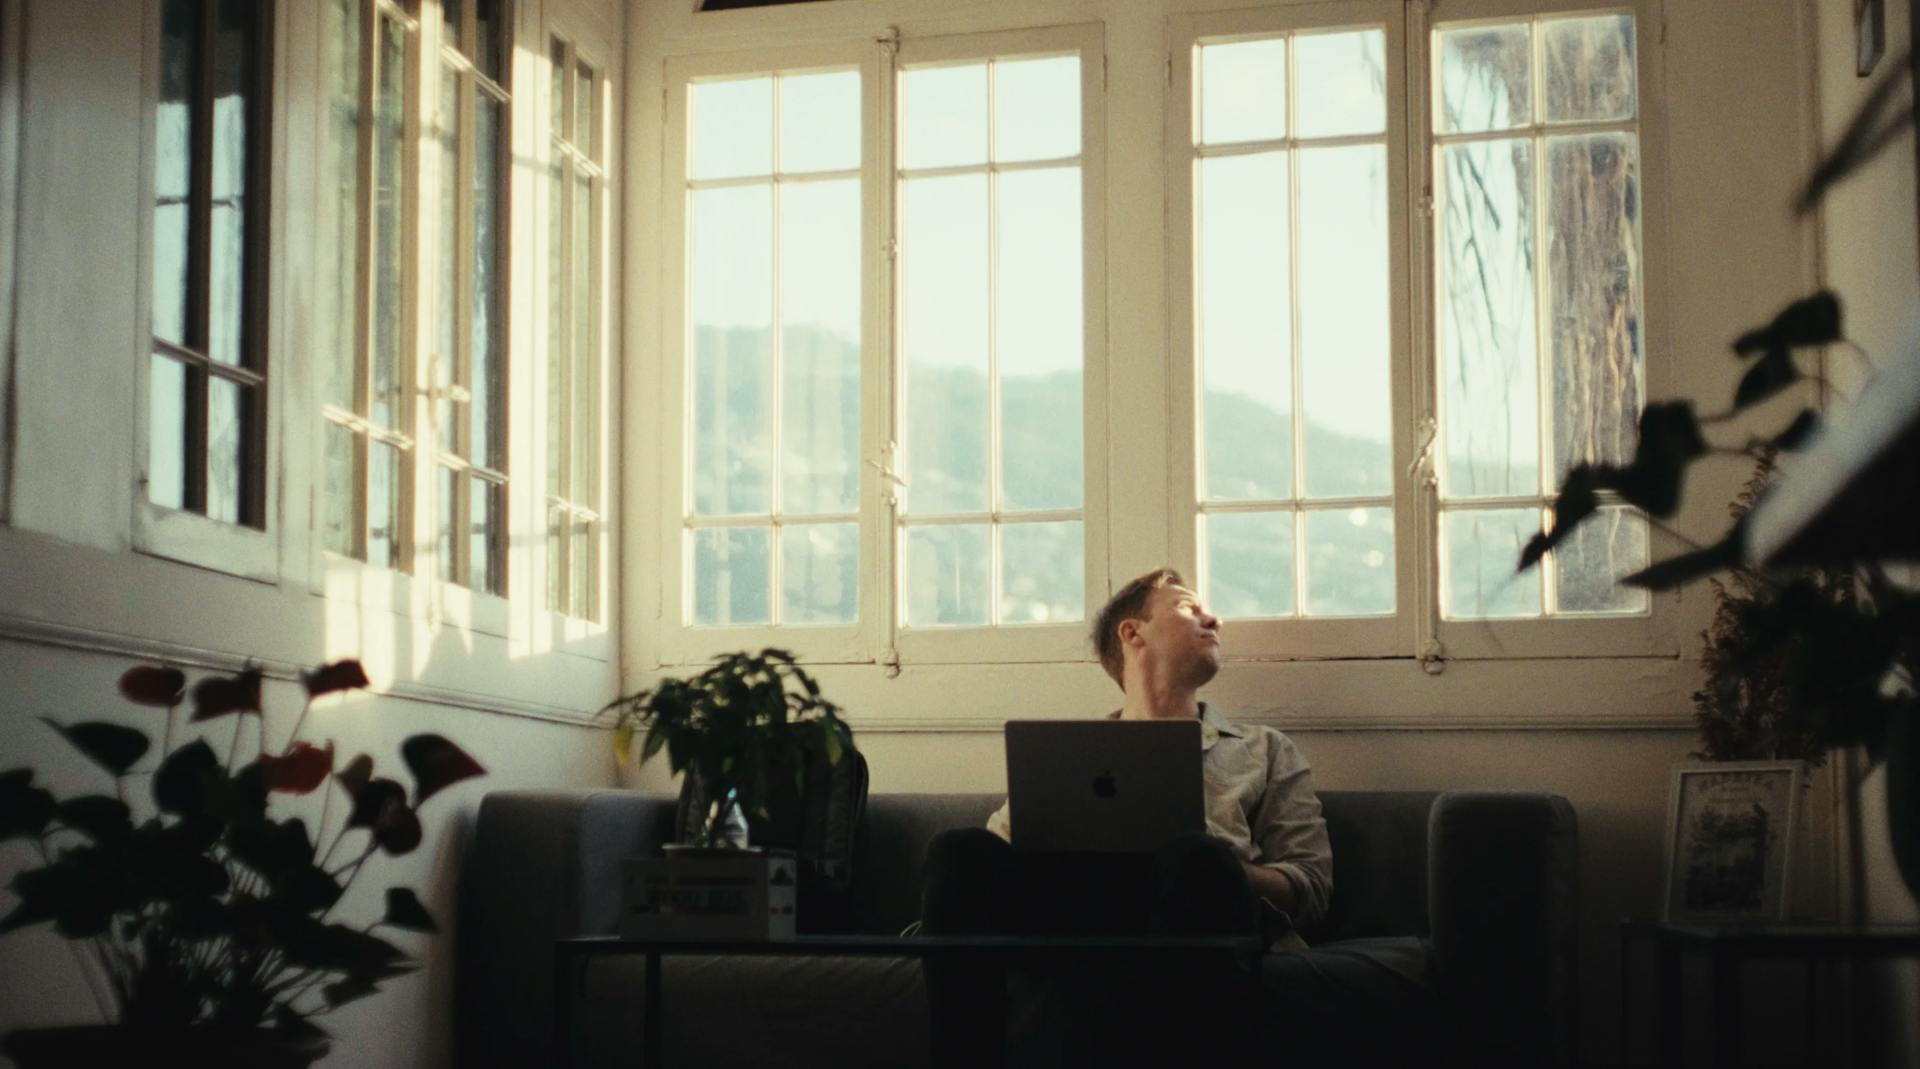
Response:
[1165,0,1421,660]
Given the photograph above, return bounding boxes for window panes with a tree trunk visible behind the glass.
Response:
[1432,13,1649,618]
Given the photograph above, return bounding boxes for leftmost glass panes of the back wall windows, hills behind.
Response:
[685,69,862,626]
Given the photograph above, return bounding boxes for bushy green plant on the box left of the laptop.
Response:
[601,649,852,848]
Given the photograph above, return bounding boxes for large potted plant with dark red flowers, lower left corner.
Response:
[0,660,484,1069]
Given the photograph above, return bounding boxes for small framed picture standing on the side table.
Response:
[1661,762,1807,921]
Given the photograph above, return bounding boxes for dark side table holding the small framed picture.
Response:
[1620,919,1920,1069]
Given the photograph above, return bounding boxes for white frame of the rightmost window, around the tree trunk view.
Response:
[1407,0,1684,660]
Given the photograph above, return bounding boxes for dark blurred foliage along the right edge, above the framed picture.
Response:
[1519,54,1920,896]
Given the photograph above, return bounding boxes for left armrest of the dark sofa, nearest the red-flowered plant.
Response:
[453,791,674,1067]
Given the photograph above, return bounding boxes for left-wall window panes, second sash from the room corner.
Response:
[426,0,513,595]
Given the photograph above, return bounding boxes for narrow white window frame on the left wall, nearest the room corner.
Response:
[537,8,624,662]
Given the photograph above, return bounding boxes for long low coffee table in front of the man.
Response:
[553,935,1263,1069]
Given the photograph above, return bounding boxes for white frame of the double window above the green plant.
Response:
[657,25,1110,664]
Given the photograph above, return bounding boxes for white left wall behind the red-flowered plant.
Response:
[0,0,624,1069]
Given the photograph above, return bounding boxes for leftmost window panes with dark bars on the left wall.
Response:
[144,0,273,530]
